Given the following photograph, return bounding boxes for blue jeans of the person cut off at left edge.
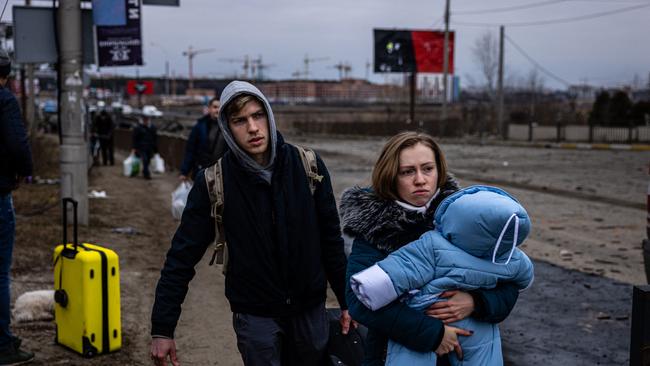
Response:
[0,193,16,350]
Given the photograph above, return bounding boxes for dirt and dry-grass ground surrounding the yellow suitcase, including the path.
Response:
[12,149,241,365]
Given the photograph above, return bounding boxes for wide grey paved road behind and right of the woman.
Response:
[293,136,650,365]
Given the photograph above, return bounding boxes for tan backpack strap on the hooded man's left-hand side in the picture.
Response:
[205,158,228,273]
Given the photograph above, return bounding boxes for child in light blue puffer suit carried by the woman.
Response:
[350,186,533,366]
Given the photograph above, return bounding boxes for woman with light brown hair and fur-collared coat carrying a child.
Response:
[340,132,518,366]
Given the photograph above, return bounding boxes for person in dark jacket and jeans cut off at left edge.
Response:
[0,49,34,365]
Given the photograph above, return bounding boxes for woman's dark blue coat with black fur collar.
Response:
[340,176,518,365]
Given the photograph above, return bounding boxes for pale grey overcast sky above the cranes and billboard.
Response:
[0,0,650,88]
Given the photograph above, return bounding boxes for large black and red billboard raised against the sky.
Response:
[374,29,454,74]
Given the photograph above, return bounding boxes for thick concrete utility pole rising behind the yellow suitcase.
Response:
[57,0,88,225]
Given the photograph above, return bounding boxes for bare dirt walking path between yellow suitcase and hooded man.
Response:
[83,156,241,365]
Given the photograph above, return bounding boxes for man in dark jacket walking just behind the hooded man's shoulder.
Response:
[179,97,226,181]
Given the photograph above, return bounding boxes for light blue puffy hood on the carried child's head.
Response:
[434,186,531,262]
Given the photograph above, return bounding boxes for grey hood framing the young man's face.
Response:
[219,80,278,177]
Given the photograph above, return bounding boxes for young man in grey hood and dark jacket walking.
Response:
[151,81,351,366]
